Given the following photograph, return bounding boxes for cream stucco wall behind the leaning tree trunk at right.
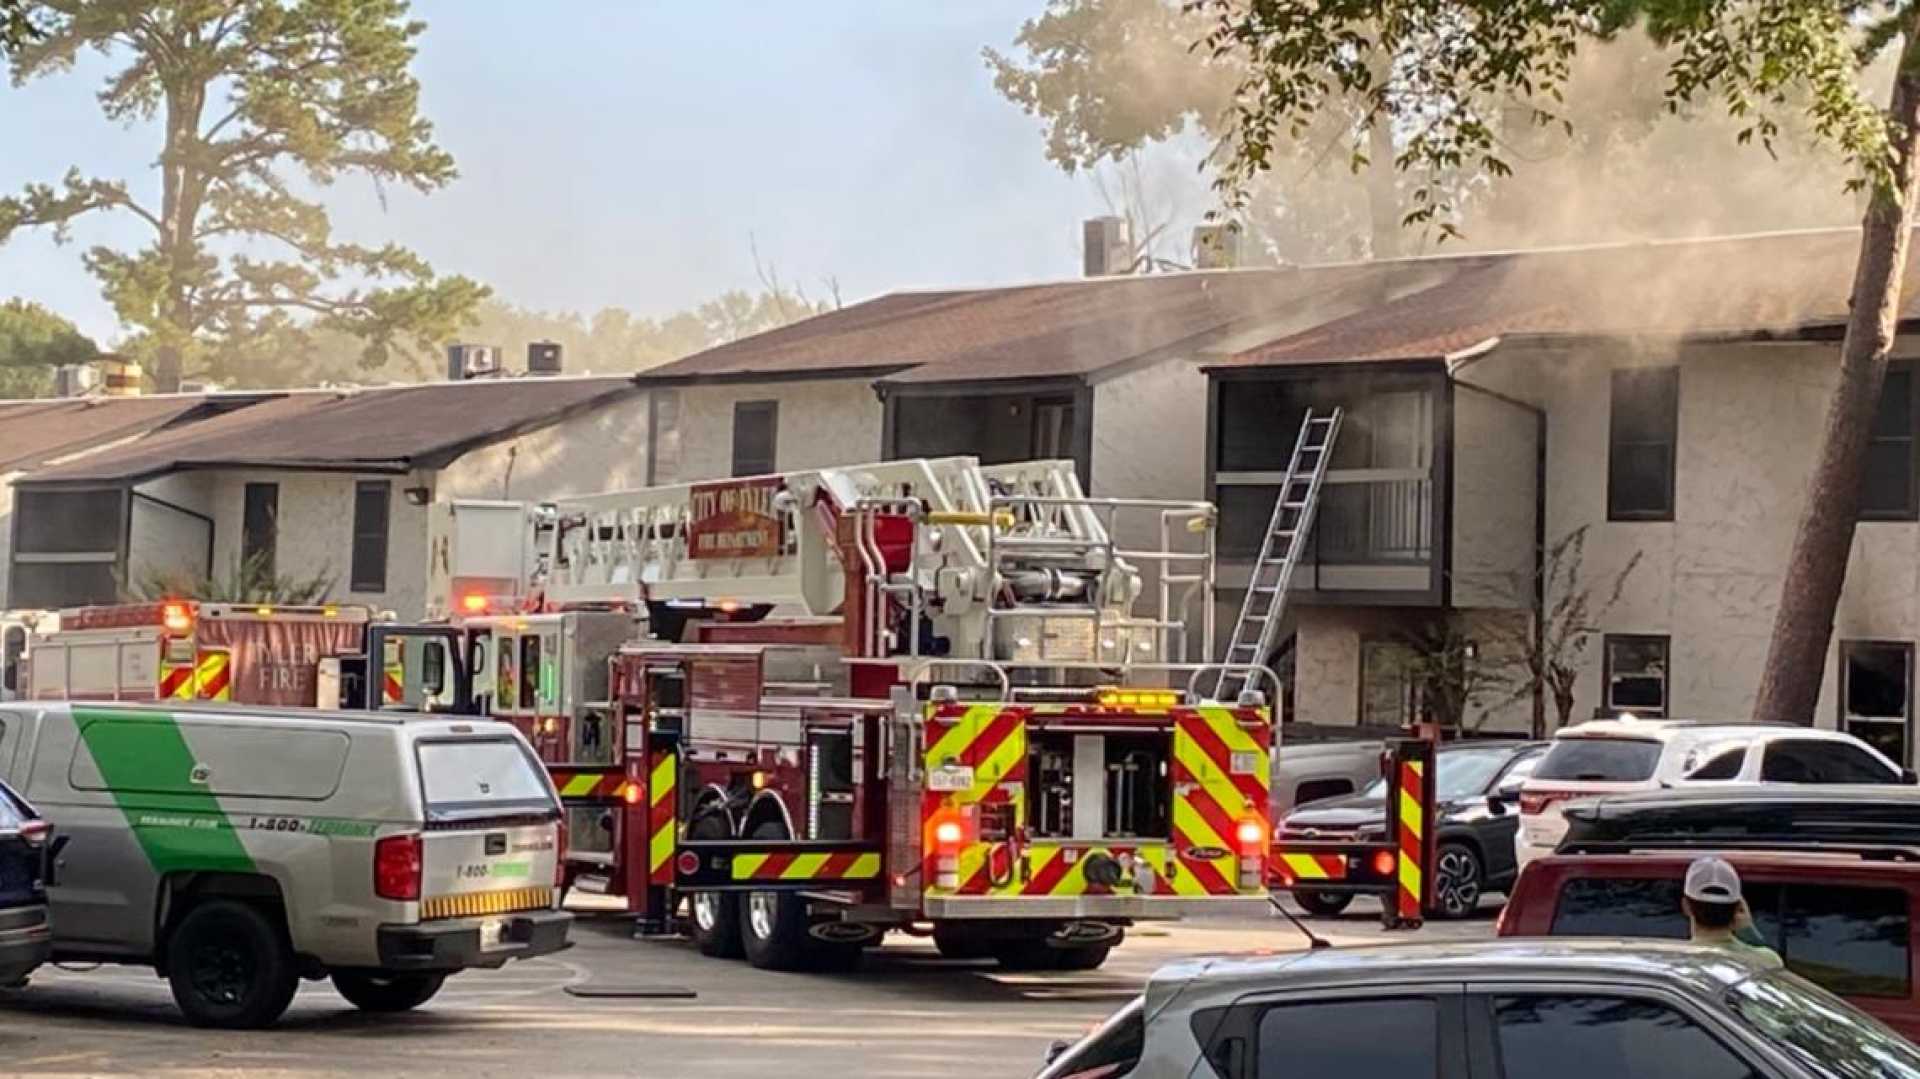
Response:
[1469,340,1920,726]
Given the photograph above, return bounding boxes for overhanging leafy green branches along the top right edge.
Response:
[1188,0,1912,234]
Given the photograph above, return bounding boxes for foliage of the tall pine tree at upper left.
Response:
[0,0,488,388]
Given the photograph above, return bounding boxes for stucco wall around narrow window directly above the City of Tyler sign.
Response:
[680,378,881,480]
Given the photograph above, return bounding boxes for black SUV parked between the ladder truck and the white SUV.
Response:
[1279,741,1548,918]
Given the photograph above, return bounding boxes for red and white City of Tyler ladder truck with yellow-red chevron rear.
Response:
[401,457,1273,970]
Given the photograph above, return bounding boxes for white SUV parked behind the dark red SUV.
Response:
[1513,718,1912,868]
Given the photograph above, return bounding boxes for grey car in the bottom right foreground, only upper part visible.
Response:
[1039,941,1920,1079]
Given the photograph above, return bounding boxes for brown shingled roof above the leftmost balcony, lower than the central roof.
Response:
[31,376,639,482]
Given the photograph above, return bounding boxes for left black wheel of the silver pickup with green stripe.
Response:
[167,899,300,1031]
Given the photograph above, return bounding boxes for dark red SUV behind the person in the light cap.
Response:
[1498,787,1920,1043]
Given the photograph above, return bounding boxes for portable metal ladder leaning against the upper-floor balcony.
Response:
[1213,407,1342,701]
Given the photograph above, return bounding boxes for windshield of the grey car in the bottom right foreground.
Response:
[1728,959,1920,1079]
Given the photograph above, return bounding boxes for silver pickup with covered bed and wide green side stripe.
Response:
[0,703,572,1027]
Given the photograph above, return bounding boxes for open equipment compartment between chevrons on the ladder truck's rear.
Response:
[1029,730,1173,839]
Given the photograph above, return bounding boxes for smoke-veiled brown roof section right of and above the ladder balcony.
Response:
[1219,228,1920,367]
